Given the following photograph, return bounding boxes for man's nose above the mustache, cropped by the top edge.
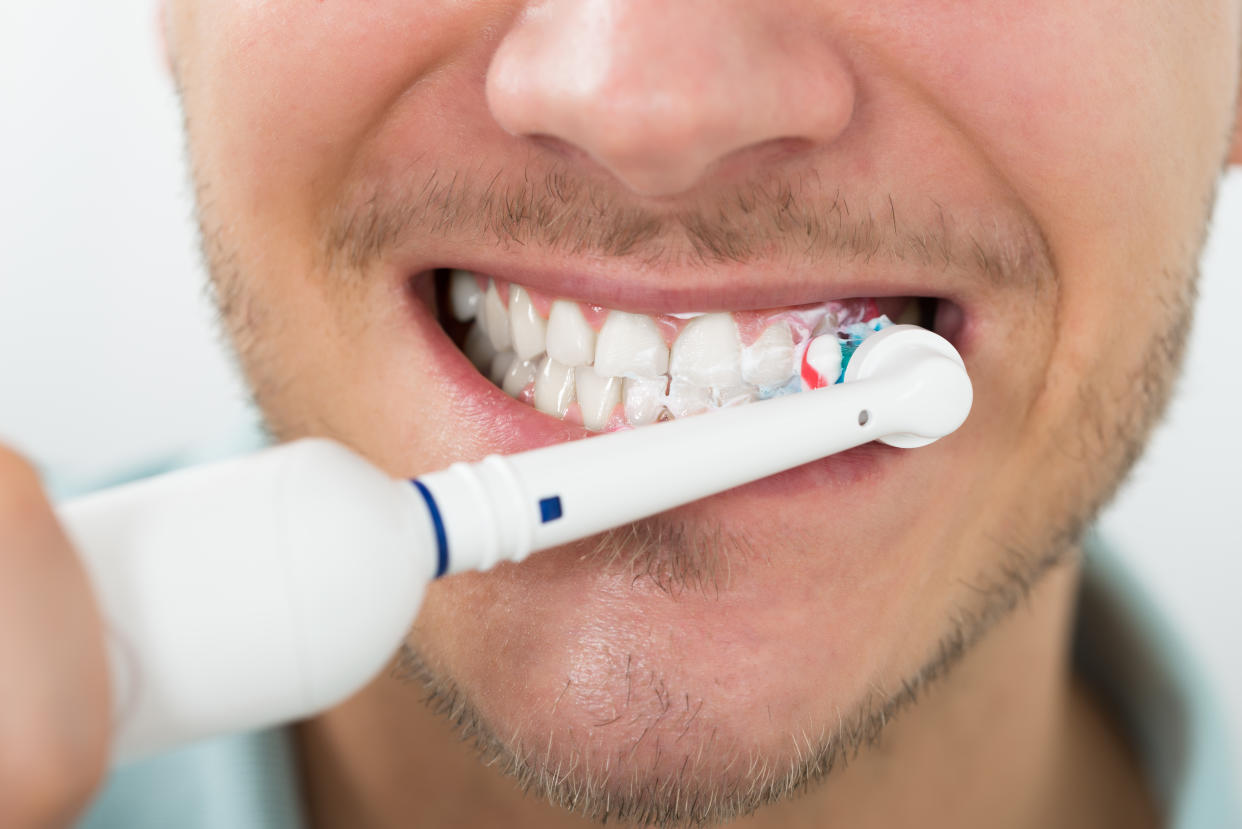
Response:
[487,0,854,196]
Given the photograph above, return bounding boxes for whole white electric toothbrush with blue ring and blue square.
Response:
[58,326,972,763]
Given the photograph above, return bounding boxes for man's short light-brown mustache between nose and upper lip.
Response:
[320,165,1054,290]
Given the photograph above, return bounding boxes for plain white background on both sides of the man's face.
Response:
[0,0,1242,787]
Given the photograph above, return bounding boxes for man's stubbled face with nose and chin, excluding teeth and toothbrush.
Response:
[168,0,1240,817]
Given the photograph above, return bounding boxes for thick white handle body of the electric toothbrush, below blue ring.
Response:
[57,440,437,762]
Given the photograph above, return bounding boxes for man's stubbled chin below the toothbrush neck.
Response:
[406,452,935,818]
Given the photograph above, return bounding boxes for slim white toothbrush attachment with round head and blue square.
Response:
[419,326,972,572]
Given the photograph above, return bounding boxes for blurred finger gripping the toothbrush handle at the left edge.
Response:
[0,446,111,827]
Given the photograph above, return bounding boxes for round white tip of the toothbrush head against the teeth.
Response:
[845,326,974,449]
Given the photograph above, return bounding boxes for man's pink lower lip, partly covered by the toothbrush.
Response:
[411,282,907,509]
